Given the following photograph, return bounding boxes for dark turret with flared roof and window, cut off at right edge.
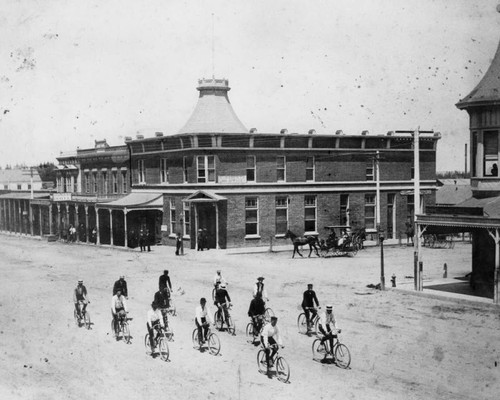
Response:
[456,35,500,198]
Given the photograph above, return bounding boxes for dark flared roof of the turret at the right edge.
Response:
[456,43,500,110]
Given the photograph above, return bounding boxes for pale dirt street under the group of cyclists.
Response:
[0,235,500,400]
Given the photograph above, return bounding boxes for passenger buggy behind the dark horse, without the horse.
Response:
[319,225,364,257]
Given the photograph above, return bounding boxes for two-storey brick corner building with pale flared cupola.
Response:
[126,79,440,249]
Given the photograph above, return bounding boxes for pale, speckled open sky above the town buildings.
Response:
[0,0,500,171]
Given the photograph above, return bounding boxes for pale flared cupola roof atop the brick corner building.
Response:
[179,78,248,134]
